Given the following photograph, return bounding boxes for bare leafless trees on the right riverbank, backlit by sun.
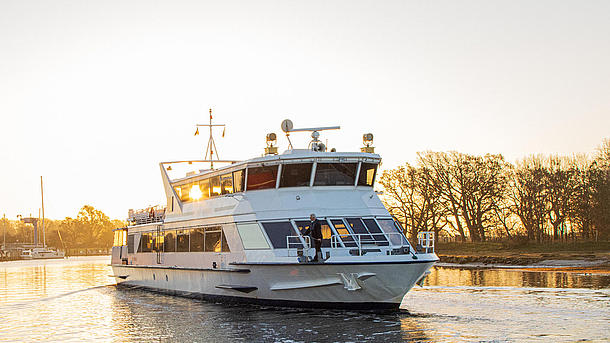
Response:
[379,139,610,242]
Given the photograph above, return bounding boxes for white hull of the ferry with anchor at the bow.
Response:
[112,260,434,310]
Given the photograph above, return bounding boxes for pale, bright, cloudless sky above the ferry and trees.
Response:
[0,0,610,219]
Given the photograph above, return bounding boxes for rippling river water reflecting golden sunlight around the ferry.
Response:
[0,257,610,342]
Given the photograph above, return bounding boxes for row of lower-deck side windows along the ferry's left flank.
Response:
[127,226,230,253]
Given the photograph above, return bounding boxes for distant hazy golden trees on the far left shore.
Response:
[0,205,126,249]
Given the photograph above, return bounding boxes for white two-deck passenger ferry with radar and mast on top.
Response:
[111,115,438,310]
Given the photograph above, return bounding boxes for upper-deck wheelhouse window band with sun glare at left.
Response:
[174,163,377,202]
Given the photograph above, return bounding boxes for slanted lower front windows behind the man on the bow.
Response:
[256,218,406,249]
